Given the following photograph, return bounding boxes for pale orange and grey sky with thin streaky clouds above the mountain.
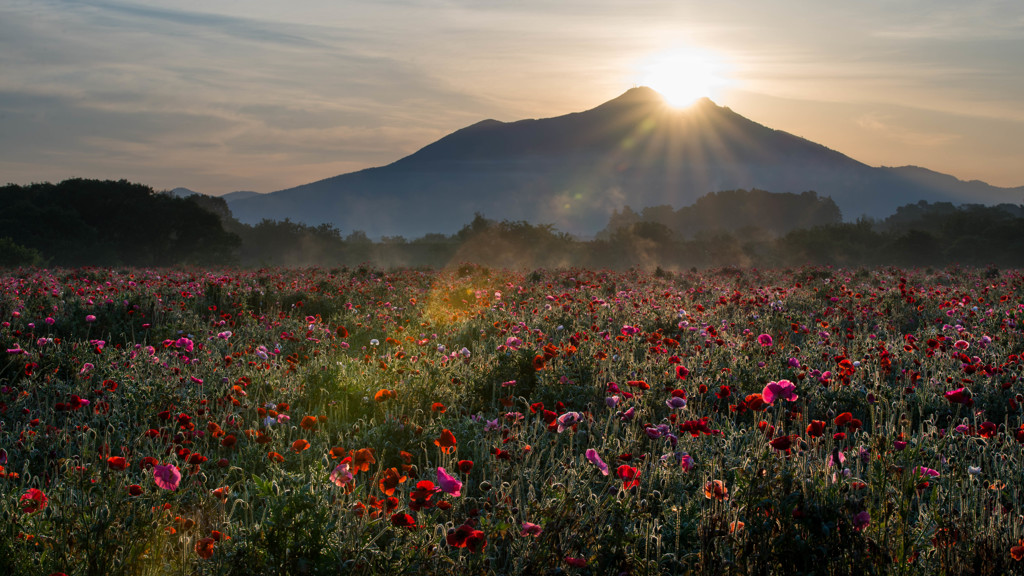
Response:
[6,0,1024,195]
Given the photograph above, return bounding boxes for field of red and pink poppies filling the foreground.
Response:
[0,264,1024,575]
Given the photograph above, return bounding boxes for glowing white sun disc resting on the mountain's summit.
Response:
[640,47,729,108]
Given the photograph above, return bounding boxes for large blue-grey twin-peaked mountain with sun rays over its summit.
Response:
[228,87,1024,238]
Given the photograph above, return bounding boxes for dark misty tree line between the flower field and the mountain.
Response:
[0,179,1024,270]
